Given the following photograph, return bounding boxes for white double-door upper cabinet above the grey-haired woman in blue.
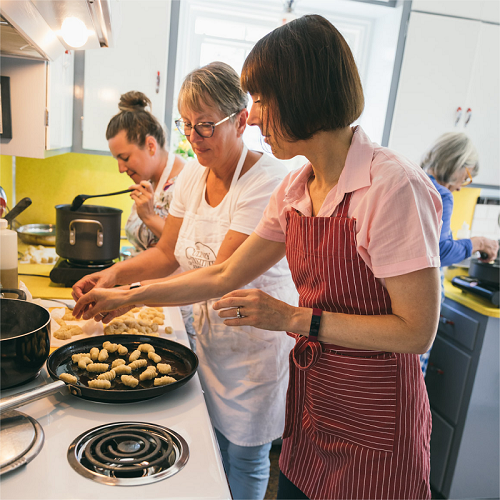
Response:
[389,12,500,186]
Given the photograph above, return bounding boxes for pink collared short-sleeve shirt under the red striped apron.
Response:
[255,126,442,278]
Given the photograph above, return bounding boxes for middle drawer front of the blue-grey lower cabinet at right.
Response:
[425,336,471,424]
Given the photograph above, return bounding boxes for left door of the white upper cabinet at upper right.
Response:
[389,12,481,163]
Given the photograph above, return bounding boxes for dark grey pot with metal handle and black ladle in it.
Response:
[56,205,122,264]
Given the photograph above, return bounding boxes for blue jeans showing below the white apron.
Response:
[215,429,272,500]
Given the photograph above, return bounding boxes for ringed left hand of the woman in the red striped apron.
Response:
[213,289,297,331]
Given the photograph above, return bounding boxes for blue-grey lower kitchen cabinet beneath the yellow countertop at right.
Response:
[425,298,500,498]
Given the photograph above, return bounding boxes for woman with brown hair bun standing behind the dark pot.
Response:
[106,90,185,253]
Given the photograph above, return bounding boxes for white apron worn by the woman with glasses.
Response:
[175,147,297,446]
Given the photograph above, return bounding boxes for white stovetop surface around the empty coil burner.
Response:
[0,308,231,500]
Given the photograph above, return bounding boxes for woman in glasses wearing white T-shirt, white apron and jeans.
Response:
[73,63,298,499]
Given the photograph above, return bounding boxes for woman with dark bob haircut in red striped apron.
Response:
[75,16,442,499]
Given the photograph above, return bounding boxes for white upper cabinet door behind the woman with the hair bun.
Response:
[82,0,171,151]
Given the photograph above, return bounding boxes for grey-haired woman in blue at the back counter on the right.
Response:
[420,132,498,375]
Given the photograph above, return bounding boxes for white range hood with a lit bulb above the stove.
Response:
[0,0,118,61]
